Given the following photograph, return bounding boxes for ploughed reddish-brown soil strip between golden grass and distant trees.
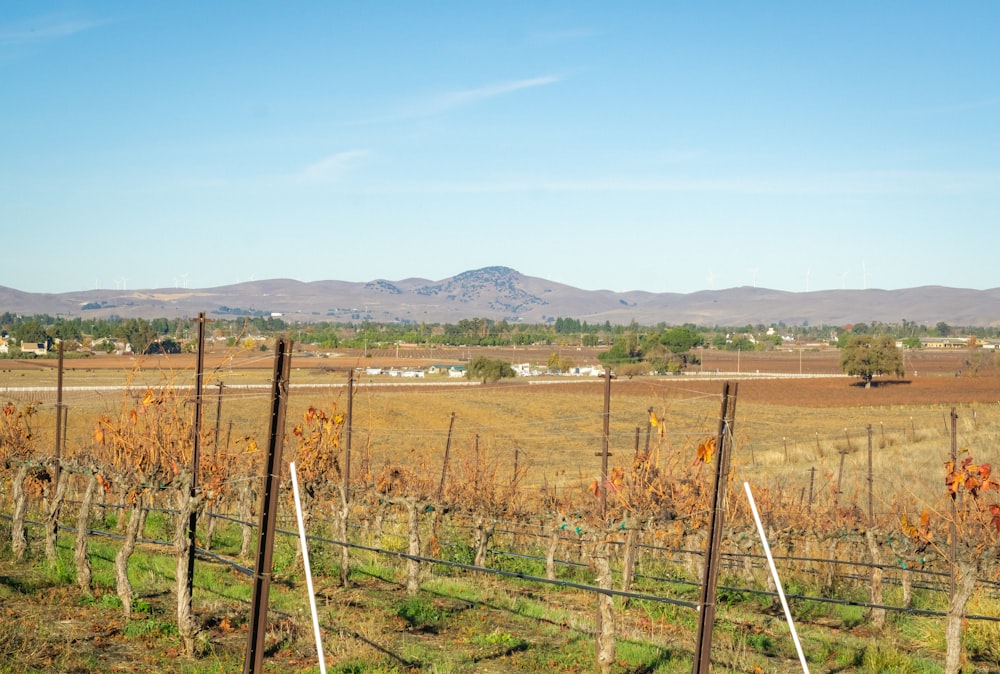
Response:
[0,346,1000,407]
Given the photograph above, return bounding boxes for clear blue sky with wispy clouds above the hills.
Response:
[0,0,1000,293]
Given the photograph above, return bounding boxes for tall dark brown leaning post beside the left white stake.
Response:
[243,337,292,674]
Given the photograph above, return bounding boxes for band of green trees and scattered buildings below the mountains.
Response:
[0,312,1000,360]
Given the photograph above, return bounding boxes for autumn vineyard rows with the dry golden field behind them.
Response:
[0,344,1000,672]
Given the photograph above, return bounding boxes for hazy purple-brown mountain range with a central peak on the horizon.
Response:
[0,267,1000,327]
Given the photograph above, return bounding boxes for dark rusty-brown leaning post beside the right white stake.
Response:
[693,381,738,674]
